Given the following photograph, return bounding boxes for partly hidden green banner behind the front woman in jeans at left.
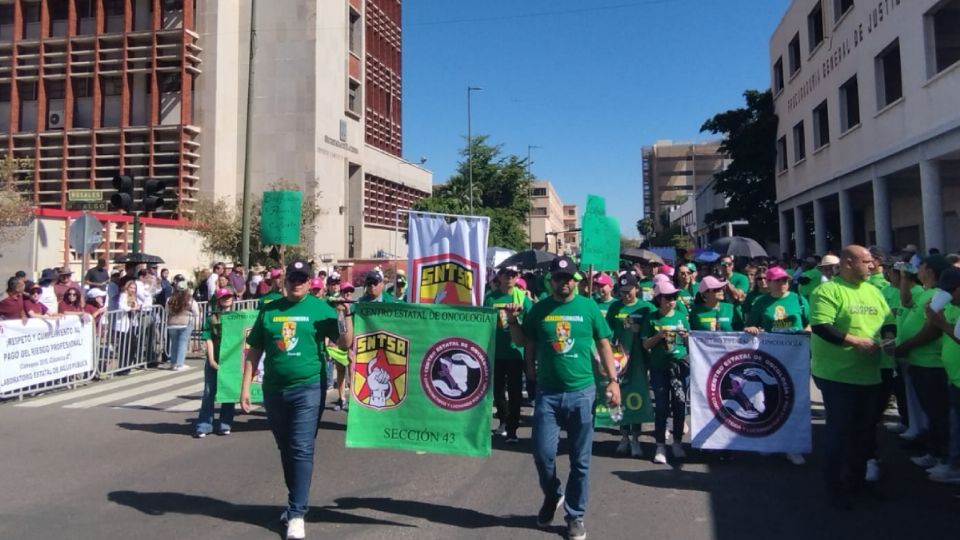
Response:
[216,309,263,403]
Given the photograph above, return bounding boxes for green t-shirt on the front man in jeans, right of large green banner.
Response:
[523,295,613,392]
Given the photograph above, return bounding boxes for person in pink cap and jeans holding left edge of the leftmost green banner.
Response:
[194,289,236,439]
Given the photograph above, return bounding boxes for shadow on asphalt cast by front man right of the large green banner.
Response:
[323,497,544,532]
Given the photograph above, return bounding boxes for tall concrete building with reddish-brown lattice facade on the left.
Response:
[0,0,432,276]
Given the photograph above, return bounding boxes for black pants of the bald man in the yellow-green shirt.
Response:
[814,377,880,494]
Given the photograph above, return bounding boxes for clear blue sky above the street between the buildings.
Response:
[403,0,789,236]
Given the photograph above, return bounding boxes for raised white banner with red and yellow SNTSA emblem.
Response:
[407,212,490,306]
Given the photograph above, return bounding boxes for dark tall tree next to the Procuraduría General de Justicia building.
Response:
[700,90,779,242]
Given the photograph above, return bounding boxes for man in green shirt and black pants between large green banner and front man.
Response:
[483,266,533,444]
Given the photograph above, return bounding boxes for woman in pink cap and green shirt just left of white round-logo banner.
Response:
[640,281,690,464]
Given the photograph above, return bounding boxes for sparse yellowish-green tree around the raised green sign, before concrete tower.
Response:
[191,180,323,264]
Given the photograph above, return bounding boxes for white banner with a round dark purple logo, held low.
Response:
[690,332,811,454]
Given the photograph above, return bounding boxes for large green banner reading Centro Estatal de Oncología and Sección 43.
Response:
[346,303,497,456]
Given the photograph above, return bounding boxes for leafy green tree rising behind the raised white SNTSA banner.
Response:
[414,135,531,250]
